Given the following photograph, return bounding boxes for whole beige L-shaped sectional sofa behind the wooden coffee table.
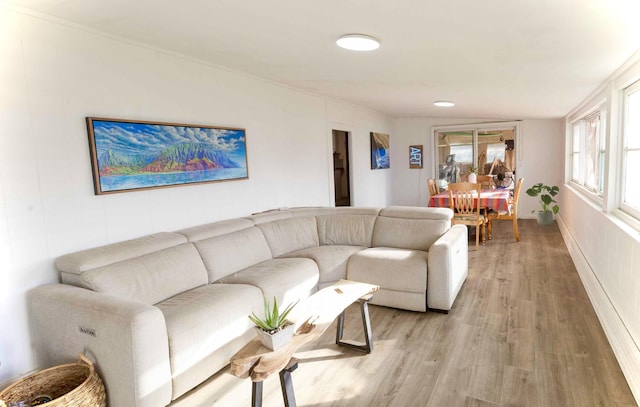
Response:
[29,207,468,407]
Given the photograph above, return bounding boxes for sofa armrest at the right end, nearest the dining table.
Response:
[427,225,469,311]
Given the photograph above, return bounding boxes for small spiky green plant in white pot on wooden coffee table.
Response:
[249,296,299,350]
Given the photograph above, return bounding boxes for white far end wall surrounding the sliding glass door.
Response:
[391,118,564,210]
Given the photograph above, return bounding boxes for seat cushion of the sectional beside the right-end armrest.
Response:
[347,247,428,293]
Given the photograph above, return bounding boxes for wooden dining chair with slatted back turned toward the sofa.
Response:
[448,182,487,250]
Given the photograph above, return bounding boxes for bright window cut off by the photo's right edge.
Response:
[620,81,640,218]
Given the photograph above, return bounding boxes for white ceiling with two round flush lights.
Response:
[5,0,640,120]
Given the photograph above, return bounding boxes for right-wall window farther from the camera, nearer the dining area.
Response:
[570,110,606,195]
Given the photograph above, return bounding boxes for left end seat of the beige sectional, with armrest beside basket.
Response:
[29,232,263,407]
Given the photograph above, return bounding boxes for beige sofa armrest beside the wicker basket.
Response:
[28,284,172,407]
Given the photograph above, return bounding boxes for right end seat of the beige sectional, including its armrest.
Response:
[347,207,468,312]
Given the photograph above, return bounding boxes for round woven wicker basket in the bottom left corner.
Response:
[0,353,107,407]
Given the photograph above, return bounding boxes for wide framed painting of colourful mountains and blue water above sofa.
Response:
[87,117,249,195]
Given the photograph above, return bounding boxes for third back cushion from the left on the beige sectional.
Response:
[258,216,319,257]
